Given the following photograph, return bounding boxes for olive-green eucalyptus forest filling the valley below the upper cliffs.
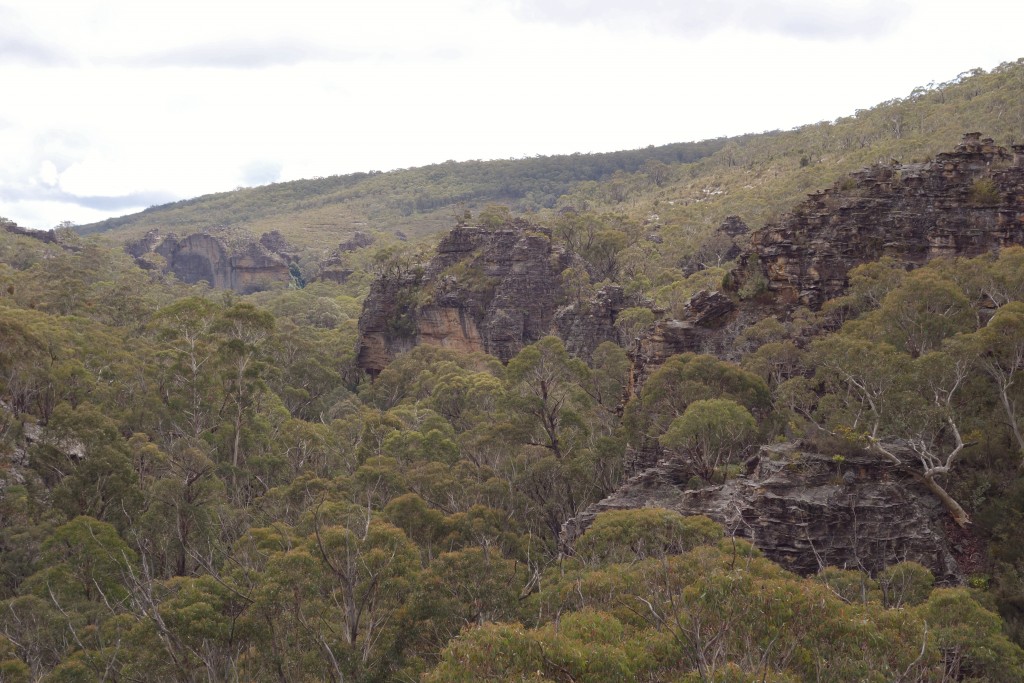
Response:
[0,223,1024,681]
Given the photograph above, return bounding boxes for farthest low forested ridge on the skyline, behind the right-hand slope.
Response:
[78,138,735,246]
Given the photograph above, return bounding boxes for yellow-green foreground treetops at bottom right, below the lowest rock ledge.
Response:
[427,542,1024,682]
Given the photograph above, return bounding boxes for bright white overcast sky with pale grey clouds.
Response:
[0,0,1024,228]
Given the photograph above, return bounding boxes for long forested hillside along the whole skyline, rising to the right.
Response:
[78,59,1024,265]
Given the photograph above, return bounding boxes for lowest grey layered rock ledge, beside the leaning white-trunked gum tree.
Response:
[562,443,963,582]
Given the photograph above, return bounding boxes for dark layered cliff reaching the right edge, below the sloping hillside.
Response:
[733,133,1024,308]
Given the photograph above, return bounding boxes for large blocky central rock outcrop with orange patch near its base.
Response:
[357,221,566,375]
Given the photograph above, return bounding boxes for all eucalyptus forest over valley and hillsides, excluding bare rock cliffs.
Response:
[6,62,1024,683]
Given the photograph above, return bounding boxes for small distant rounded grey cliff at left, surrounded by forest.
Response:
[125,231,292,294]
